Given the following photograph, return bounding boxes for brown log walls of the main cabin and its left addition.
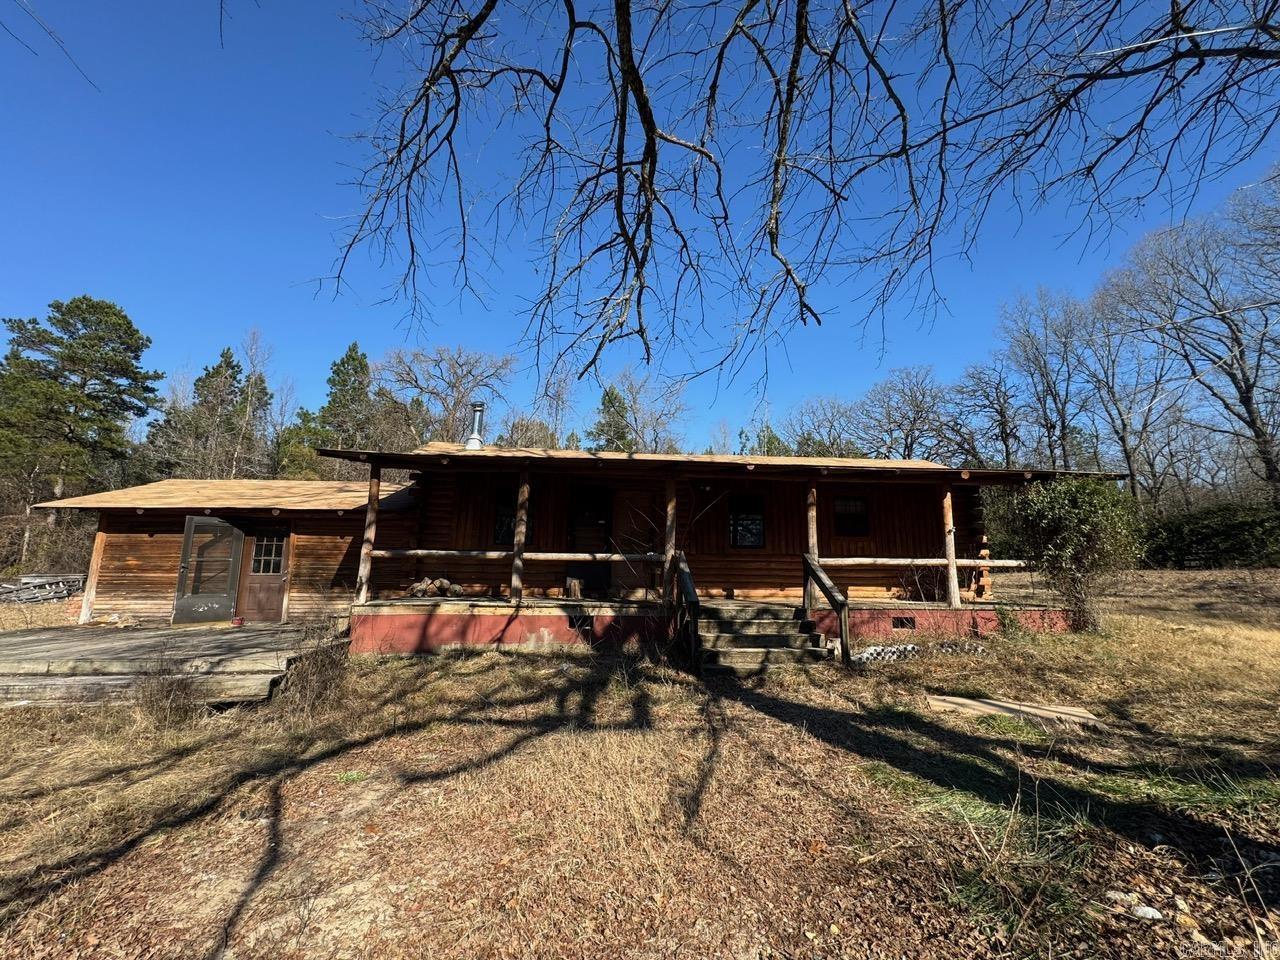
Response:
[85,470,991,620]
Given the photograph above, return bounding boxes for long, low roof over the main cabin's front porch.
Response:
[316,442,1124,484]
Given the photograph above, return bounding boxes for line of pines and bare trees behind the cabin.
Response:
[0,180,1280,570]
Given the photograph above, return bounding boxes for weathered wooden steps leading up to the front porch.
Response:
[698,600,832,676]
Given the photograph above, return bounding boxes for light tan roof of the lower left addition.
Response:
[35,480,412,511]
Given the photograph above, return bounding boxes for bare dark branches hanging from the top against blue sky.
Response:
[338,0,1280,381]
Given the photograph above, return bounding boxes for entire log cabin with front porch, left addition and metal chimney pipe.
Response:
[40,411,1085,657]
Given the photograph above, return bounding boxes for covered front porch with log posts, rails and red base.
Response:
[323,444,1070,653]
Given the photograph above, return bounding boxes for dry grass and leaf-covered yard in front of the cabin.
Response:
[0,572,1280,960]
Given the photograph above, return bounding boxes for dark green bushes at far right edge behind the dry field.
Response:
[1144,503,1280,570]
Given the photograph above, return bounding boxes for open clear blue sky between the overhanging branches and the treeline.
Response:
[0,0,1263,445]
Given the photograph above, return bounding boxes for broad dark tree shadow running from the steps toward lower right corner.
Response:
[708,677,1280,908]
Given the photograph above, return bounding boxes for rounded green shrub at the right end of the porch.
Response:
[988,476,1140,630]
